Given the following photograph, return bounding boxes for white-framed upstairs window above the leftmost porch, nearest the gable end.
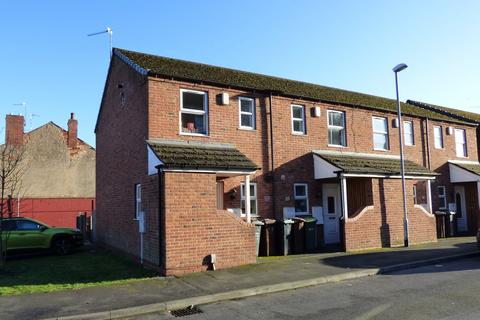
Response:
[180,89,208,136]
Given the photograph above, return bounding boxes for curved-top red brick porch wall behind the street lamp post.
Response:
[345,179,437,251]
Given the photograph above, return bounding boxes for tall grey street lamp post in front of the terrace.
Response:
[392,63,408,247]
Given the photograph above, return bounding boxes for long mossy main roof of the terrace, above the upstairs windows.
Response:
[114,48,472,123]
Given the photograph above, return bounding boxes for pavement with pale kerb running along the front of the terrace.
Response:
[0,237,478,319]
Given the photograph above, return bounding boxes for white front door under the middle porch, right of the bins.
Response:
[322,184,342,244]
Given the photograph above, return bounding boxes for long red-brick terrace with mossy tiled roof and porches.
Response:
[96,49,478,275]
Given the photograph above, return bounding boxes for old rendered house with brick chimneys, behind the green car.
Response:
[3,113,95,227]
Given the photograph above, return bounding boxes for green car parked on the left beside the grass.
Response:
[1,218,83,255]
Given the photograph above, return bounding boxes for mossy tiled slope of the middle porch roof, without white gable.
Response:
[314,151,439,176]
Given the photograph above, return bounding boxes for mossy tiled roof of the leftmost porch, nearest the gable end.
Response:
[147,140,258,173]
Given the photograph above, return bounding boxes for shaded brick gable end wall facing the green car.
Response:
[96,57,151,261]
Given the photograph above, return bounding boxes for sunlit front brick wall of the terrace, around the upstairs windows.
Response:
[149,78,477,224]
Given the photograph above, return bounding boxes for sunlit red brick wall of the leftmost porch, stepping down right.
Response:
[164,172,256,275]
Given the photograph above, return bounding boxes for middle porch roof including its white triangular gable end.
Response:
[313,150,439,179]
